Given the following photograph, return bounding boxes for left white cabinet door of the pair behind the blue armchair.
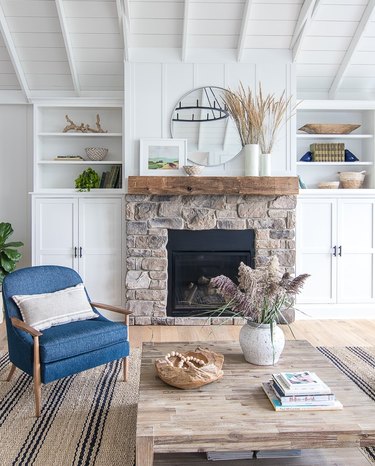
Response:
[33,198,78,270]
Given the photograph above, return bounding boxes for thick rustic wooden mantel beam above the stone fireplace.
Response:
[128,176,298,196]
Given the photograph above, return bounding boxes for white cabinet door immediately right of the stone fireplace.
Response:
[296,199,337,304]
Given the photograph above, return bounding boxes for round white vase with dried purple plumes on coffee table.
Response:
[210,256,309,365]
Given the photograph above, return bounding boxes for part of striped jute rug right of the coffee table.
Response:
[318,346,375,464]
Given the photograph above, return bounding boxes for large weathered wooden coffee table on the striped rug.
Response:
[136,341,375,466]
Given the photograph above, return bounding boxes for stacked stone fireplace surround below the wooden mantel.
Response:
[126,195,296,325]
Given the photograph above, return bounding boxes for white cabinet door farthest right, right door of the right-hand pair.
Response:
[337,199,374,303]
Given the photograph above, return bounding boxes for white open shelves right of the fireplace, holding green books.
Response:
[296,100,375,189]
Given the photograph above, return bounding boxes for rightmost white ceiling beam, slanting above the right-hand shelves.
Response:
[328,0,375,99]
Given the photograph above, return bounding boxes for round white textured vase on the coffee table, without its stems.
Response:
[240,322,285,366]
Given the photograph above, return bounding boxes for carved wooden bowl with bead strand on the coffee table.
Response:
[155,348,224,390]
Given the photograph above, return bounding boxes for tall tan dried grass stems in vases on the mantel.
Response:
[224,83,291,154]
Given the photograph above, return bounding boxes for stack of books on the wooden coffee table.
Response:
[262,371,342,411]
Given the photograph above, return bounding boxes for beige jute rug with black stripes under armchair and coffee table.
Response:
[0,347,375,466]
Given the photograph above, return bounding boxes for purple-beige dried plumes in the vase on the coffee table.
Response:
[210,256,310,324]
